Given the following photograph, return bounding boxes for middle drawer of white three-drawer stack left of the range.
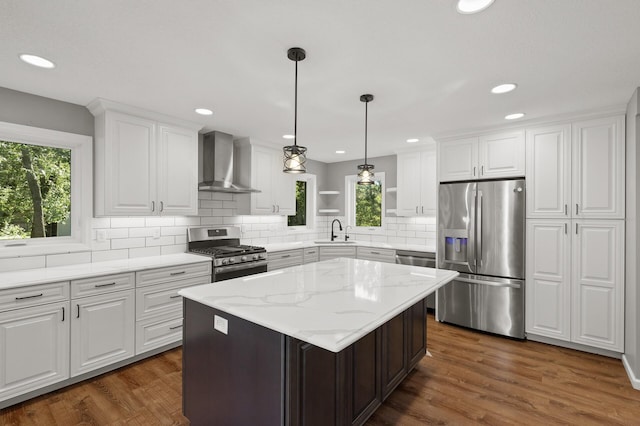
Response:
[136,275,211,320]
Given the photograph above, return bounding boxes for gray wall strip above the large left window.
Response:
[0,87,93,137]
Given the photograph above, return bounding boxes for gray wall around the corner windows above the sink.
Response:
[318,155,397,216]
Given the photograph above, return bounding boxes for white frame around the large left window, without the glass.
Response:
[0,121,93,258]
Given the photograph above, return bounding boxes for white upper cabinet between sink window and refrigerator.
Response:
[396,149,437,216]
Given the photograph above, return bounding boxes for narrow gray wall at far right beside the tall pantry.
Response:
[624,88,640,379]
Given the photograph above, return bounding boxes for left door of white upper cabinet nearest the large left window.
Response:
[104,111,158,215]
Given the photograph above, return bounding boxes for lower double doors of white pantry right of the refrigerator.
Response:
[526,219,624,352]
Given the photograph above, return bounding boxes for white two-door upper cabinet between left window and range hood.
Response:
[88,99,200,216]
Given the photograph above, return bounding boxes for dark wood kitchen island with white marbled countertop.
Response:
[180,258,458,426]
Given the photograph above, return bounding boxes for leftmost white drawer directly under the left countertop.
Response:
[0,281,69,312]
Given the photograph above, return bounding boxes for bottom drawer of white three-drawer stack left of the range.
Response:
[136,312,182,355]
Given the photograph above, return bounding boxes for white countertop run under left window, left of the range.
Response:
[0,253,211,290]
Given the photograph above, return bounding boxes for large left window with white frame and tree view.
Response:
[0,122,93,257]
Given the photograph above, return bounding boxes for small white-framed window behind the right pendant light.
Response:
[345,172,385,232]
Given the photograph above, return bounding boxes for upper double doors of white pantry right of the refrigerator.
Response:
[526,116,625,219]
